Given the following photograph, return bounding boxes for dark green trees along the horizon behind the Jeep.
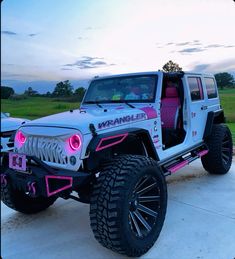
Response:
[1,60,235,99]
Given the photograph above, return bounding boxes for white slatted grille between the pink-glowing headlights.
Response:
[19,136,68,165]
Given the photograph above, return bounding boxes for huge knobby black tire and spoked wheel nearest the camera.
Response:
[90,155,167,256]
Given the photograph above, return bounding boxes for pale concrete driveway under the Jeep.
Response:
[1,161,235,259]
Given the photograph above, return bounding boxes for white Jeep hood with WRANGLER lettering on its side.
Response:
[23,107,156,134]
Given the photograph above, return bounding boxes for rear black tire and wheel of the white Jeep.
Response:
[201,124,233,174]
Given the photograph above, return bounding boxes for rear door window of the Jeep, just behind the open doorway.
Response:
[188,77,204,101]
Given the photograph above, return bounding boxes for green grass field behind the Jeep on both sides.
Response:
[1,89,235,143]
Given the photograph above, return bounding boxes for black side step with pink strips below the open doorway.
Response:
[161,144,209,176]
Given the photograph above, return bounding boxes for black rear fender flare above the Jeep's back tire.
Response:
[203,109,226,140]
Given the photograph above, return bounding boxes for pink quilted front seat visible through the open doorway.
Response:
[161,87,180,129]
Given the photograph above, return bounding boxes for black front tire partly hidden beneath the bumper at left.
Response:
[1,183,57,214]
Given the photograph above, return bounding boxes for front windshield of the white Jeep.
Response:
[83,75,157,104]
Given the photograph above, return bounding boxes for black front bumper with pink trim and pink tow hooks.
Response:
[1,153,94,197]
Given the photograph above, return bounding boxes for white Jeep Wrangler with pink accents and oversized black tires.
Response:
[1,71,232,256]
